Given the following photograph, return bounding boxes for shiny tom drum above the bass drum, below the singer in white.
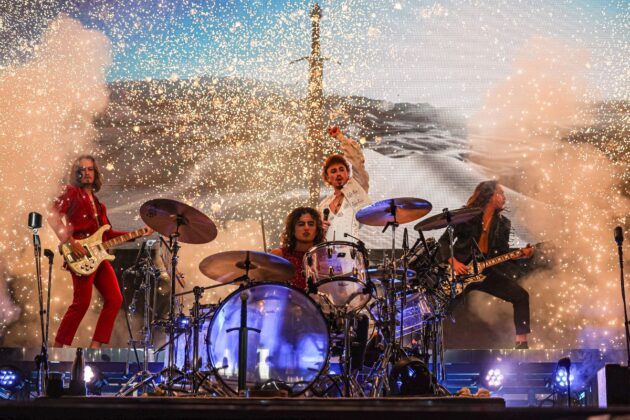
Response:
[304,241,370,313]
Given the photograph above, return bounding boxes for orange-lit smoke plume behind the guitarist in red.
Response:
[0,15,111,345]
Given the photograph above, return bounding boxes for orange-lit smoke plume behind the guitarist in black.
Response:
[471,38,630,348]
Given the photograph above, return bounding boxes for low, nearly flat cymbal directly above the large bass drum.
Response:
[199,251,293,283]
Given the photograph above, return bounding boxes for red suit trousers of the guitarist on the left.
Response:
[56,261,122,346]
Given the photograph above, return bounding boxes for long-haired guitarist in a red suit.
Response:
[48,155,153,348]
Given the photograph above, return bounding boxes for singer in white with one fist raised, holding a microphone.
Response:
[318,127,371,241]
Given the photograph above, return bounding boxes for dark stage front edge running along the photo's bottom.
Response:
[0,397,630,420]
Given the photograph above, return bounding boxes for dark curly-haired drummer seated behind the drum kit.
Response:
[271,207,324,290]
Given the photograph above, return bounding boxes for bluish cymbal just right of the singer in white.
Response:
[356,197,433,226]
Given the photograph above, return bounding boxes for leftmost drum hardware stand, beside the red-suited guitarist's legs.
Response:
[116,240,157,397]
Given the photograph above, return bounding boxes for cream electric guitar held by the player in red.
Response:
[59,225,148,276]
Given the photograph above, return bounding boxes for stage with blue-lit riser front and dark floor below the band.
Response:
[0,348,630,419]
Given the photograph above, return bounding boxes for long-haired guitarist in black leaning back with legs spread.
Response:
[439,181,534,349]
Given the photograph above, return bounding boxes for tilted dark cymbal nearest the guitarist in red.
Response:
[140,198,217,244]
